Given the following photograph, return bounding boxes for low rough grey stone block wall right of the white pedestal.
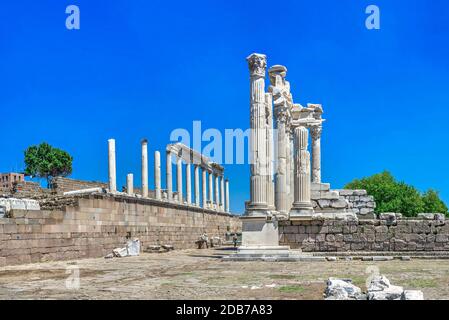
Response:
[279,219,449,252]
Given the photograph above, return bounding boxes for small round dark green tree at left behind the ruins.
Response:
[25,142,73,186]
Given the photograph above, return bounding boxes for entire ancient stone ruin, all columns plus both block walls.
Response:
[0,54,449,266]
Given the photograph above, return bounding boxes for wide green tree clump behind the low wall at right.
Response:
[345,171,448,217]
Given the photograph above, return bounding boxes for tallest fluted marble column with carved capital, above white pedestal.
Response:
[247,53,268,216]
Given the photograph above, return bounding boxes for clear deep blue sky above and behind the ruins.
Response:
[0,0,449,212]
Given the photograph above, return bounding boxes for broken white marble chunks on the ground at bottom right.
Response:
[324,275,424,300]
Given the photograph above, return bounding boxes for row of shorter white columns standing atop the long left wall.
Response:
[108,139,230,212]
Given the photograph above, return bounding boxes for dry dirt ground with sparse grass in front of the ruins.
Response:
[0,248,449,300]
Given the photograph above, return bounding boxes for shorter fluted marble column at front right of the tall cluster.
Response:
[290,127,313,216]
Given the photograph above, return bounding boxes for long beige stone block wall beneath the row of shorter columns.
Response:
[0,194,241,266]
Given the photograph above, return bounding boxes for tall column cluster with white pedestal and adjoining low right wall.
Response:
[232,53,449,260]
